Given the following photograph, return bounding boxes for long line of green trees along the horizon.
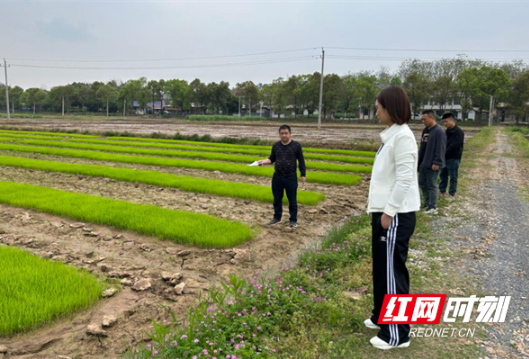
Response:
[0,56,529,123]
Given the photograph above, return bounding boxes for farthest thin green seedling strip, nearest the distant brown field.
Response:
[0,130,376,158]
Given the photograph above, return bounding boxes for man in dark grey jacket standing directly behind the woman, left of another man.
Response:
[418,110,446,215]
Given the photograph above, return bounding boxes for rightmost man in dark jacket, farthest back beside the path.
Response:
[439,113,465,198]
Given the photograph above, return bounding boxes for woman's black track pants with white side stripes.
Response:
[371,212,415,346]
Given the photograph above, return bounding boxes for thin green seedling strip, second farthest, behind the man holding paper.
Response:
[0,131,374,165]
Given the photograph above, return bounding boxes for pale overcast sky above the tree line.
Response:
[0,0,529,89]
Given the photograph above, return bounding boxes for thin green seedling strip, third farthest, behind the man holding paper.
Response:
[0,138,372,173]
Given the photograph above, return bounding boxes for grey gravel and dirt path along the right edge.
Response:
[433,130,529,358]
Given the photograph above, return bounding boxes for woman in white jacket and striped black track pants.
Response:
[364,86,421,349]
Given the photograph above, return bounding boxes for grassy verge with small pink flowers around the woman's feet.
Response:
[125,214,477,359]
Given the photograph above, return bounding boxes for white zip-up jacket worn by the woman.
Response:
[367,124,421,217]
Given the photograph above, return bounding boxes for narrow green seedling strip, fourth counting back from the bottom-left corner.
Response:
[0,144,362,186]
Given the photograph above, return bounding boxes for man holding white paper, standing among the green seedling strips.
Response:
[257,125,307,228]
